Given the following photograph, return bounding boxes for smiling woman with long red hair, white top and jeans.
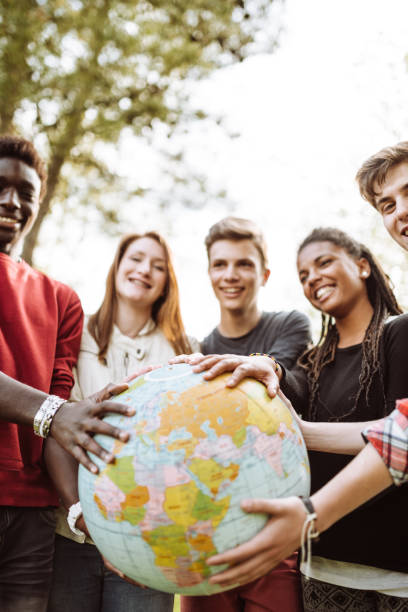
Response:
[48,232,198,612]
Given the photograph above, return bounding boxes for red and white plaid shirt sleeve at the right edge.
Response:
[363,399,408,485]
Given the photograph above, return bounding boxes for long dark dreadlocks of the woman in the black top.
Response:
[298,227,402,420]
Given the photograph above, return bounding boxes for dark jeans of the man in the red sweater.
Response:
[0,506,55,612]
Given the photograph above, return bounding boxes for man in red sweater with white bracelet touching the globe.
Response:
[0,136,131,612]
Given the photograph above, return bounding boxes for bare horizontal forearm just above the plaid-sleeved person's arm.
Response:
[301,421,384,455]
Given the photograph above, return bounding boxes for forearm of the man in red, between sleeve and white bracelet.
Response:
[0,372,48,425]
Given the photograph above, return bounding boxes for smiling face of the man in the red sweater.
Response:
[0,157,41,254]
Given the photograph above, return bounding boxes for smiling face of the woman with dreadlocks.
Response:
[297,241,370,318]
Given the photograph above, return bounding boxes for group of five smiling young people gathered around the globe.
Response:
[0,137,408,612]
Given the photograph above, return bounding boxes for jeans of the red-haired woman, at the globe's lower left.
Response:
[48,535,173,612]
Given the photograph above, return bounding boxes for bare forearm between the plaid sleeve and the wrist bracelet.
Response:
[311,444,392,531]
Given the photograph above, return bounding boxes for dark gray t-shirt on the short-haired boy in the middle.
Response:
[201,310,311,368]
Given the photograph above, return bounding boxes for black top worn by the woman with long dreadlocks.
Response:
[281,315,408,573]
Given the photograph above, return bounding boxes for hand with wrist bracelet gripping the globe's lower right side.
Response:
[207,497,306,588]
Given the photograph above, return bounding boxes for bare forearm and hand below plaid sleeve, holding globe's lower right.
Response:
[207,444,392,587]
